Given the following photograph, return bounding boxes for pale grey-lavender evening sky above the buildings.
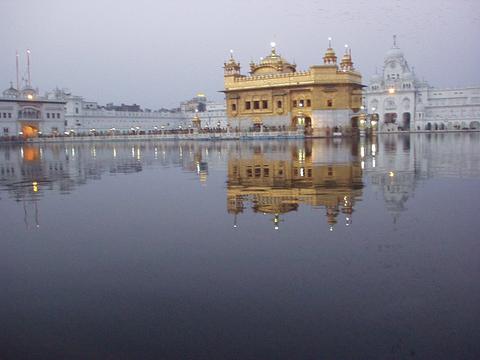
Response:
[0,0,480,109]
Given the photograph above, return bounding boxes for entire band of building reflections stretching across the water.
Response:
[0,133,480,229]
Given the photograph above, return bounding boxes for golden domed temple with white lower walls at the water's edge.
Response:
[224,44,362,136]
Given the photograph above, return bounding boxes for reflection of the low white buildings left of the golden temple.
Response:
[0,141,228,228]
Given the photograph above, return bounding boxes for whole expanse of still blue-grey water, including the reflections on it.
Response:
[0,133,480,359]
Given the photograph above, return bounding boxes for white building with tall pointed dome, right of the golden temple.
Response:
[364,37,480,132]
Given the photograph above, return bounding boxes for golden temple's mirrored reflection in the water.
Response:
[227,140,363,230]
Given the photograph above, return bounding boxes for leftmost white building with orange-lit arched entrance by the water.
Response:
[0,85,65,138]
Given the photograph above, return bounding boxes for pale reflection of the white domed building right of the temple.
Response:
[360,133,480,223]
